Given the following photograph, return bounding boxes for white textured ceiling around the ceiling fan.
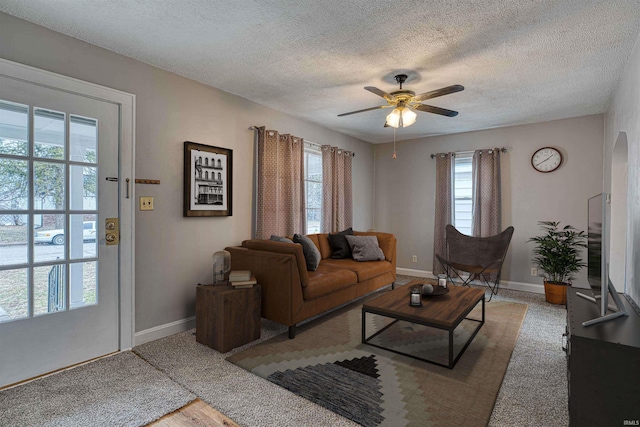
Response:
[0,0,640,143]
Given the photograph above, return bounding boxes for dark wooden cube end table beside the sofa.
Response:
[196,285,261,353]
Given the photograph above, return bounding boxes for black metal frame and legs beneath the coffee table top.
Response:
[362,296,485,369]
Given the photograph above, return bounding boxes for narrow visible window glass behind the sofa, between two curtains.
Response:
[304,148,322,234]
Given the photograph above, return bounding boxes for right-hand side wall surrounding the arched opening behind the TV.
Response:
[604,29,640,303]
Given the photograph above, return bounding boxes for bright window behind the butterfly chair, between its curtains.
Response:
[453,153,473,236]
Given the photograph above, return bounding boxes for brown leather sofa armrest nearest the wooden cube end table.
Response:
[226,243,307,326]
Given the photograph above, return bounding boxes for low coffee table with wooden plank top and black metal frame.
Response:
[362,279,485,369]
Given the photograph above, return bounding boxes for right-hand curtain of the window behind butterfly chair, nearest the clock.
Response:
[472,148,502,237]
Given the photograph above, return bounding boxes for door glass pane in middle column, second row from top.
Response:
[33,162,65,210]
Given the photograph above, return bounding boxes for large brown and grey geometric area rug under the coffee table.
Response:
[227,301,527,427]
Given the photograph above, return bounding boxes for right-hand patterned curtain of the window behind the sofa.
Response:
[322,145,353,233]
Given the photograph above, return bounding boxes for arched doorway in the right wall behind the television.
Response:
[609,132,629,292]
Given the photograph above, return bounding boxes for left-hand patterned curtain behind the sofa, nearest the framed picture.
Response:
[255,126,306,239]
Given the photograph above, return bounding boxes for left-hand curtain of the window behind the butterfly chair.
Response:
[432,153,455,275]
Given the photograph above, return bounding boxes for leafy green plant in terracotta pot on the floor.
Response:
[527,221,587,304]
